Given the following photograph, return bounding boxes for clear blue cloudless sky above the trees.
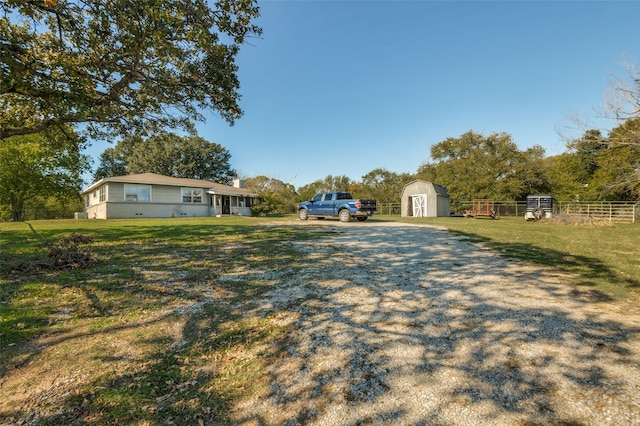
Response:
[86,0,640,187]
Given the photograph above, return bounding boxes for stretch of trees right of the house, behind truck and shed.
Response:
[246,118,640,213]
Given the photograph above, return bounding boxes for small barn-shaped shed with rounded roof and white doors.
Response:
[400,179,450,217]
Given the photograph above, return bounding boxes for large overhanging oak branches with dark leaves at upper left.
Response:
[0,0,261,139]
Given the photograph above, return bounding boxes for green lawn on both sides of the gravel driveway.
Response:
[0,217,640,425]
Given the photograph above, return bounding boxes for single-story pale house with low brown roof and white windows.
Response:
[81,173,257,219]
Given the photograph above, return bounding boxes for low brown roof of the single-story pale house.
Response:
[81,173,257,197]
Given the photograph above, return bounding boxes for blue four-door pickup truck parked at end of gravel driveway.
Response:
[298,192,376,222]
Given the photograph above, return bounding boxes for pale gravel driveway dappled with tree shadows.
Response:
[234,221,640,425]
